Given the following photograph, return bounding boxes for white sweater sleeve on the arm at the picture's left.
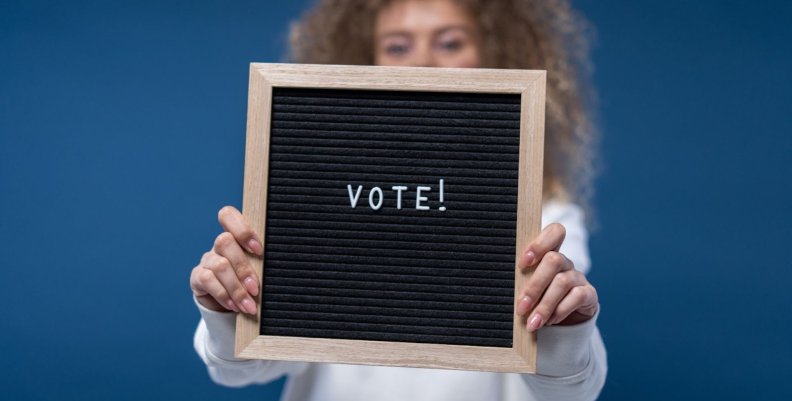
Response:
[193,300,308,387]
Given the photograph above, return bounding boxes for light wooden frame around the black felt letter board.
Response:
[235,63,546,373]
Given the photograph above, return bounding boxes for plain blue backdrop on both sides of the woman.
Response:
[0,0,792,400]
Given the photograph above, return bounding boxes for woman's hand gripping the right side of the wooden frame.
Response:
[517,223,599,331]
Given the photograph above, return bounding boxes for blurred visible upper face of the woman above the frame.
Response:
[374,0,482,67]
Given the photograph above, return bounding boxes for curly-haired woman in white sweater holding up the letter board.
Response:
[190,0,607,401]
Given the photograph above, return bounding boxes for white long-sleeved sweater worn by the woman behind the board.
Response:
[195,202,607,401]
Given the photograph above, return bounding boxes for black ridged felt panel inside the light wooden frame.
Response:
[260,87,520,347]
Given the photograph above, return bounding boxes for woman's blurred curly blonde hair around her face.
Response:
[289,0,597,209]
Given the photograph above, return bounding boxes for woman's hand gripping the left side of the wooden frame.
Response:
[190,206,264,315]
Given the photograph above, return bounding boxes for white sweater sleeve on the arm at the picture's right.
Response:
[510,202,608,401]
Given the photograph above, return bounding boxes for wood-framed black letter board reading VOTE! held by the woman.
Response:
[236,63,545,372]
